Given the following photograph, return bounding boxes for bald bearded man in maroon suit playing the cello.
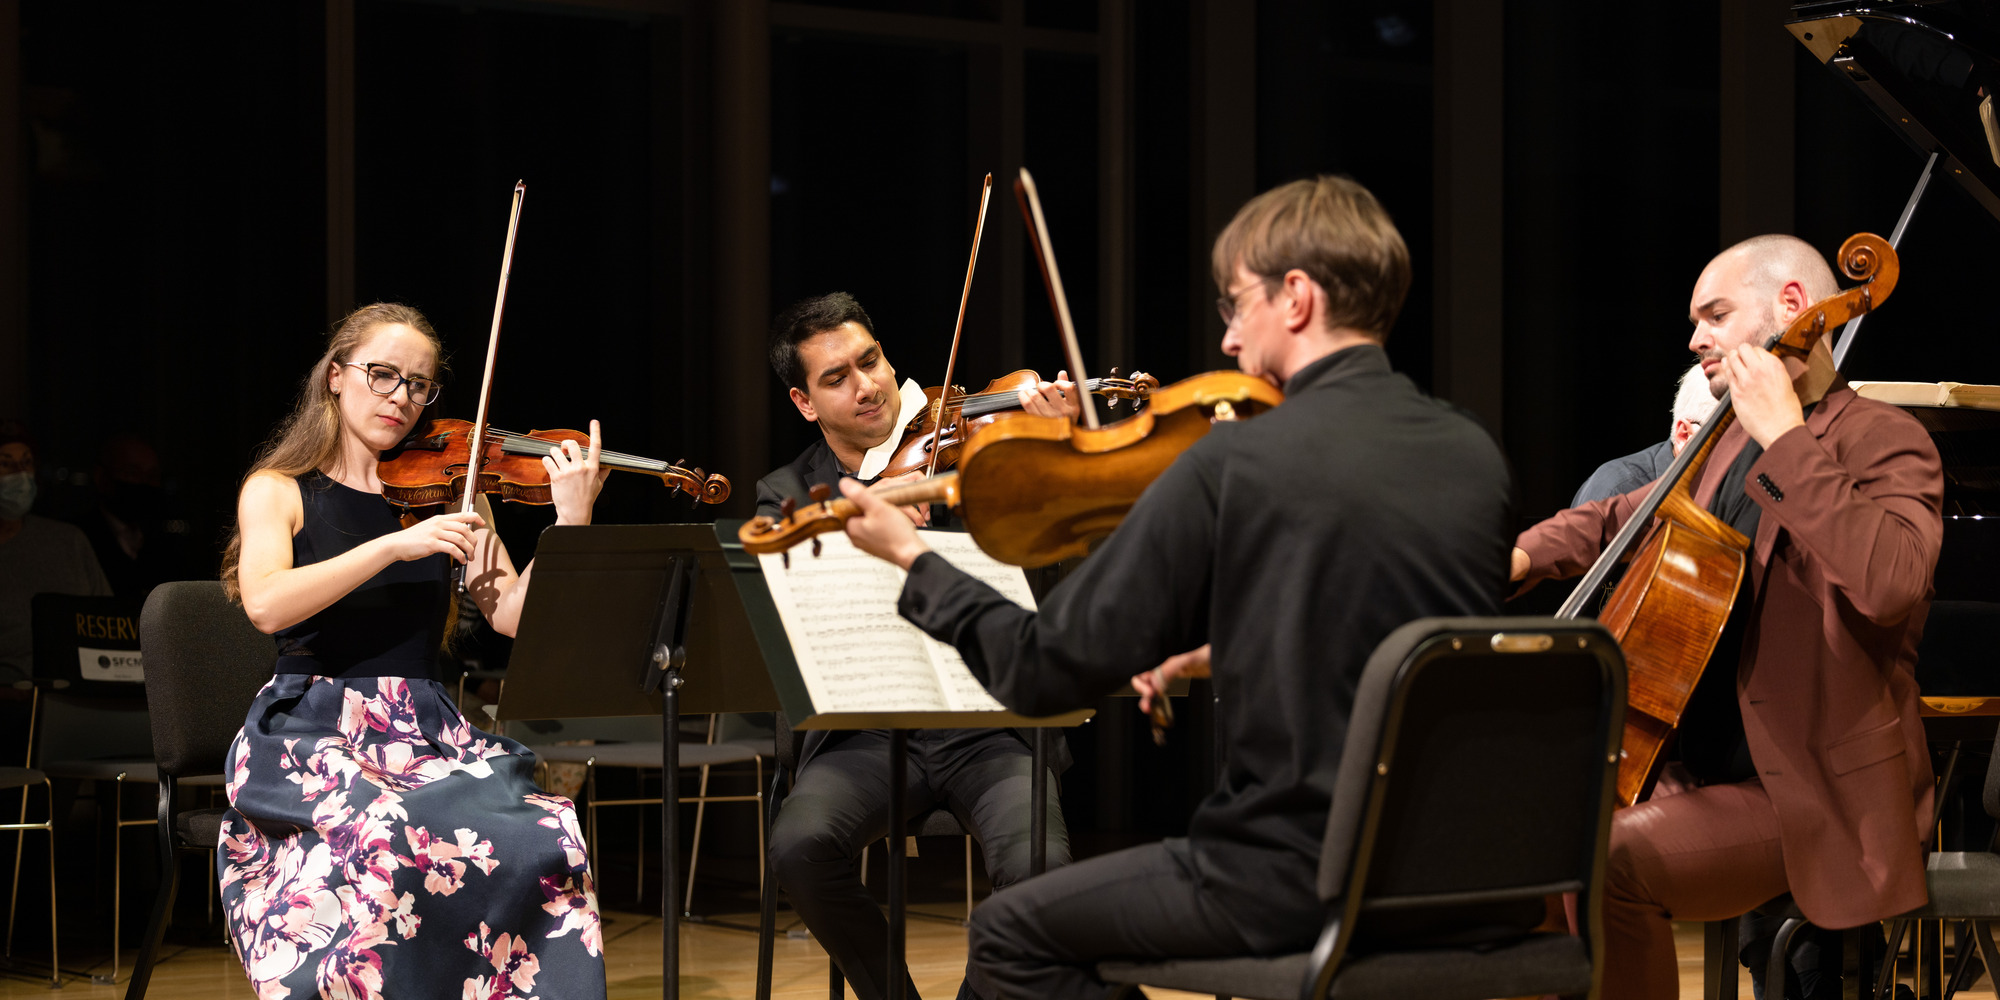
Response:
[1512,236,1944,1000]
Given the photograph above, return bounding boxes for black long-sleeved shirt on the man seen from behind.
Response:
[902,346,1512,940]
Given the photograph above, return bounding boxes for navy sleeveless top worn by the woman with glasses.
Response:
[278,472,452,680]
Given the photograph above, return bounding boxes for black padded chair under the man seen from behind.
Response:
[1098,618,1626,1000]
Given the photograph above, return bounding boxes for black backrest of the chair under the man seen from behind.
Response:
[1318,618,1626,942]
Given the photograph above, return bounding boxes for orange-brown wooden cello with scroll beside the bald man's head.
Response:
[1556,232,1900,806]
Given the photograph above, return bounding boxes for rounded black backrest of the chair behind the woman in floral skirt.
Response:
[138,580,278,778]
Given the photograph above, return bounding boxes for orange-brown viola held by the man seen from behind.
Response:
[738,372,1284,568]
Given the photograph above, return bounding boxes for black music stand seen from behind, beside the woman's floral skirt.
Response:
[494,524,778,1000]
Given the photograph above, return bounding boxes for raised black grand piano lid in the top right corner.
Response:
[1786,0,2000,218]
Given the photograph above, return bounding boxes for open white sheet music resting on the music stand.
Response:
[758,532,1034,712]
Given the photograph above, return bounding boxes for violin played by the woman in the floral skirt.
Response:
[376,418,730,508]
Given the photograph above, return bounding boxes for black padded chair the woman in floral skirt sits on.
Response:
[124,580,278,1000]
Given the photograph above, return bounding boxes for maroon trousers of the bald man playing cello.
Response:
[1604,780,1786,1000]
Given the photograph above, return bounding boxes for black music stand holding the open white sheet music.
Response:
[720,520,1094,1000]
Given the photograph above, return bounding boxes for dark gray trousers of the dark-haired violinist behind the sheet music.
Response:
[770,730,1070,1000]
